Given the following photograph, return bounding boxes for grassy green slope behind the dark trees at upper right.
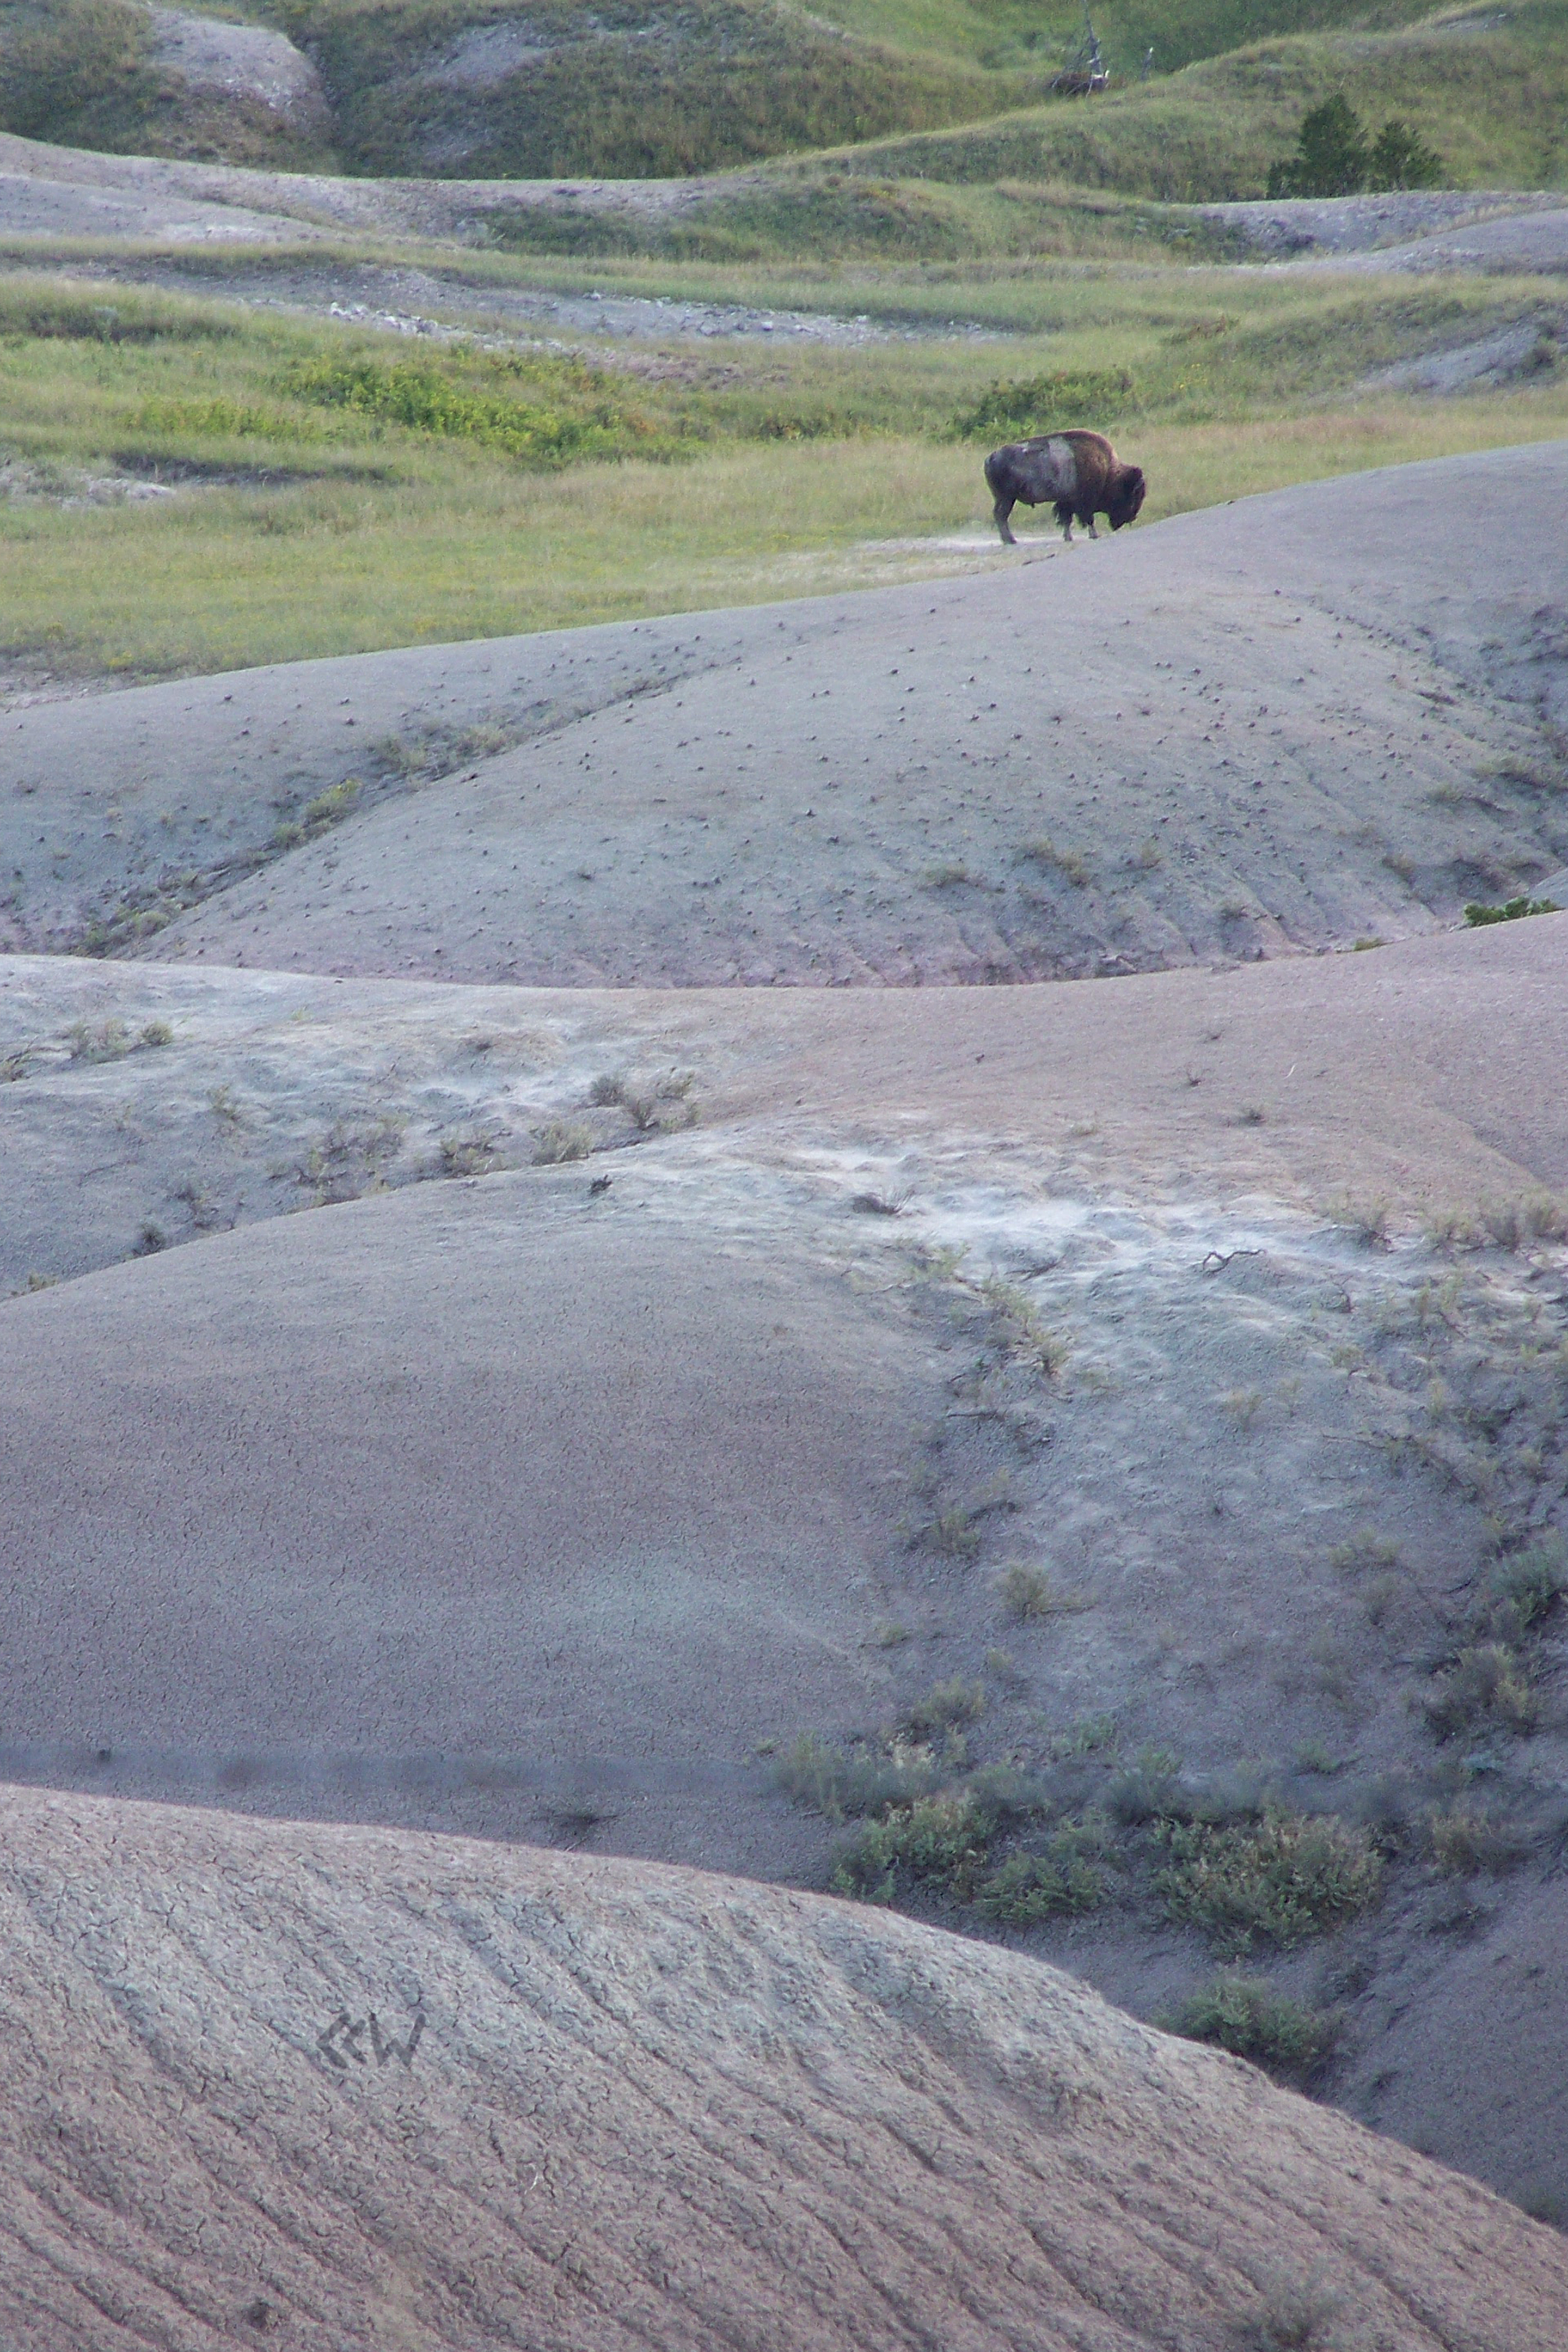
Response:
[842,0,1568,203]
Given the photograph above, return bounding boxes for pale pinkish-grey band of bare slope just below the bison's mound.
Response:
[0,894,1568,1291]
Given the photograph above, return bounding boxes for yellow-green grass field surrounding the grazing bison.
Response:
[0,256,1568,677]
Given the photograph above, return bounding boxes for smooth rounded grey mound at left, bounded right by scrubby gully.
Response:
[5,1195,940,1870]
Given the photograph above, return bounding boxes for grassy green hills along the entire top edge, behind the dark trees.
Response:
[0,0,1568,188]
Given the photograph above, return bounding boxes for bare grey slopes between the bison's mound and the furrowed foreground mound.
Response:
[0,917,1568,2211]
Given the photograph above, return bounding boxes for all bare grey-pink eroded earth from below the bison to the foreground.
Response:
[0,449,1568,2352]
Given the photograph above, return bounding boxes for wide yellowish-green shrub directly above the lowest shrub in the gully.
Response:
[1154,1806,1382,1952]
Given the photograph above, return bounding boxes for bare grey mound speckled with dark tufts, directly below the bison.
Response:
[0,442,1568,988]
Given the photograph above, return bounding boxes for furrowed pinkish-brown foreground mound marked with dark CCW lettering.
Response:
[0,1792,1568,2352]
